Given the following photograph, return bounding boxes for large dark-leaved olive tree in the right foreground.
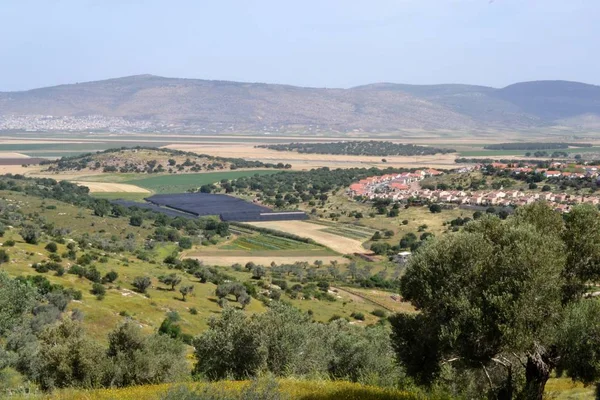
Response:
[391,203,600,399]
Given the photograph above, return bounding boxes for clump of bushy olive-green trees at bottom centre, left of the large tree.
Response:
[194,304,401,384]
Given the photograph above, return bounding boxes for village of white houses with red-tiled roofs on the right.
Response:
[348,162,600,212]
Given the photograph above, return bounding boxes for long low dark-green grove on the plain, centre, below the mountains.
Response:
[257,140,456,156]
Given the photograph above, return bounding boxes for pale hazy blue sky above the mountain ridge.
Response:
[0,0,600,90]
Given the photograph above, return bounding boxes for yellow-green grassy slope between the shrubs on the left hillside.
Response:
[2,193,264,340]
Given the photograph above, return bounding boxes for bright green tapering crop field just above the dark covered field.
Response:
[126,170,280,193]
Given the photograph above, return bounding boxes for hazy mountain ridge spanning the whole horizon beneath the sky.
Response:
[0,75,600,132]
